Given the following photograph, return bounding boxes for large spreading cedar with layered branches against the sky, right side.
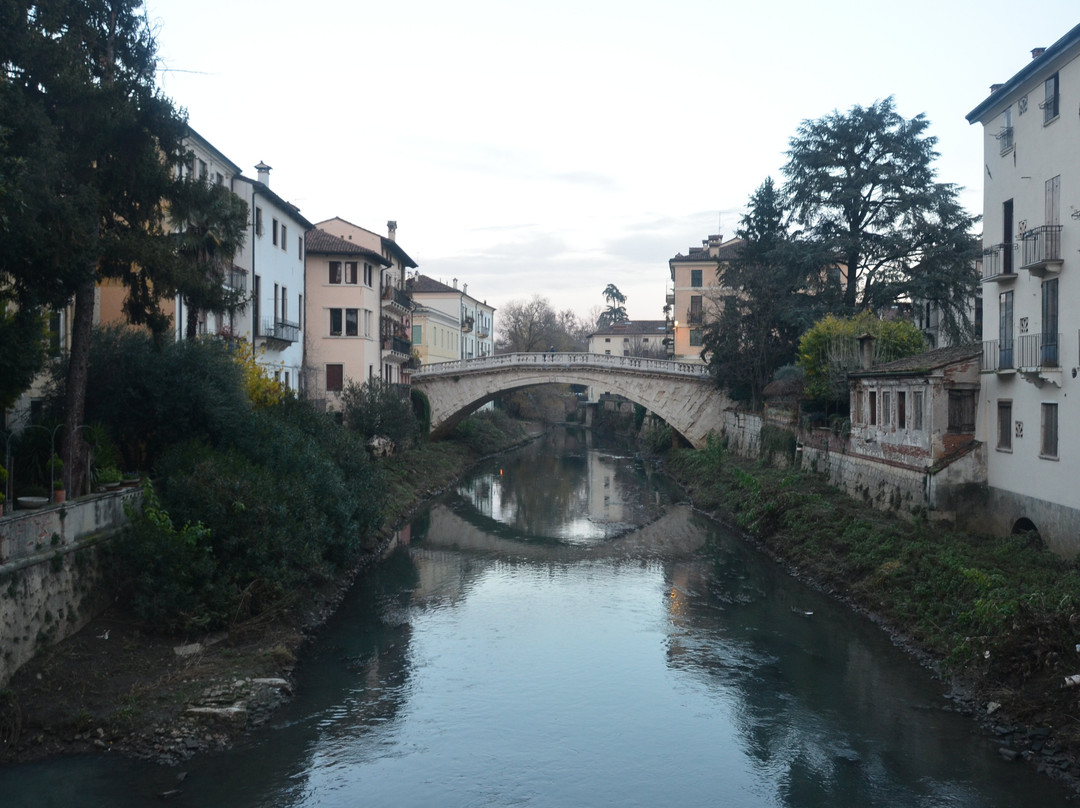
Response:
[783,97,978,341]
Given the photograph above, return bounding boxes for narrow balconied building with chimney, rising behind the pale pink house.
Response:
[315,217,417,385]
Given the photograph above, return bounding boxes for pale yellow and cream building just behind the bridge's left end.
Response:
[406,274,495,364]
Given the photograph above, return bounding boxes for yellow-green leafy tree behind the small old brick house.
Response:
[798,311,926,404]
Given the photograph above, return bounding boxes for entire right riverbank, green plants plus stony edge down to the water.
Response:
[664,443,1080,795]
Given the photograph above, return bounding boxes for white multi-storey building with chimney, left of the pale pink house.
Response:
[232,162,312,390]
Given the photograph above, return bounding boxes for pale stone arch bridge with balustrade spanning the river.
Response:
[413,353,728,448]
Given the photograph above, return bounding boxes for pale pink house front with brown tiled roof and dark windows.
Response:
[303,228,390,412]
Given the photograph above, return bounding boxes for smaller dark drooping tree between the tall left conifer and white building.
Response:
[168,174,247,339]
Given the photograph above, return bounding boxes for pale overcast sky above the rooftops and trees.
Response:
[147,0,1080,320]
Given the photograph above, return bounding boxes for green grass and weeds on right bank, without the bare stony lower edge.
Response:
[666,441,1080,712]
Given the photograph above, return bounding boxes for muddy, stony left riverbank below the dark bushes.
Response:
[0,420,542,764]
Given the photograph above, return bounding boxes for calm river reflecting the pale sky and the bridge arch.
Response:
[0,430,1067,808]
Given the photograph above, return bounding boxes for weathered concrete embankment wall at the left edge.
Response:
[0,488,143,687]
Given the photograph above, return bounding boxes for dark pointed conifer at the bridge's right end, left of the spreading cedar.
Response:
[702,177,827,408]
